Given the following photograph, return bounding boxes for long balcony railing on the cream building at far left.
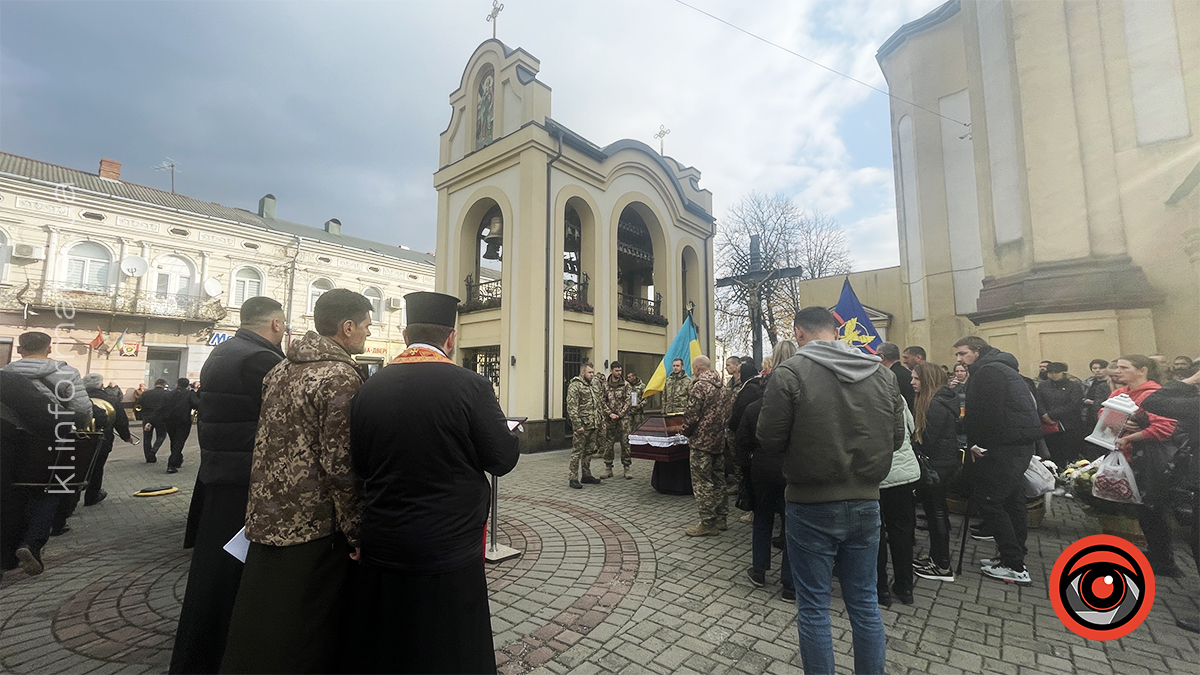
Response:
[0,281,227,323]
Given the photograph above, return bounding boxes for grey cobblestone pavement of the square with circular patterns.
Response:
[0,441,1200,675]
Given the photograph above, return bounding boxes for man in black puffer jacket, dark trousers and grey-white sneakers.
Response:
[954,335,1042,586]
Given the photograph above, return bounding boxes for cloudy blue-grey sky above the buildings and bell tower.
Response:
[0,0,941,270]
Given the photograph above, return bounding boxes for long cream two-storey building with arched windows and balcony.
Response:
[0,155,434,389]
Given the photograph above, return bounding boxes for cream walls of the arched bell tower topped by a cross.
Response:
[433,40,714,449]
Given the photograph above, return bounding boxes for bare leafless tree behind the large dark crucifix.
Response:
[714,192,851,352]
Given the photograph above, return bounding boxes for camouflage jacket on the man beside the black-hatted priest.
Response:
[246,330,362,546]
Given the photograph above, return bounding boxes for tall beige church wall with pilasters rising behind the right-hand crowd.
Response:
[863,0,1200,372]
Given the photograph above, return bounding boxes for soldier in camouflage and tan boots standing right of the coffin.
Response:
[683,356,733,537]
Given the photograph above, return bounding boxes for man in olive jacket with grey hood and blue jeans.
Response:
[756,307,905,673]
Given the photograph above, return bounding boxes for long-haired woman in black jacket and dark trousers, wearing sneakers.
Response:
[912,363,961,581]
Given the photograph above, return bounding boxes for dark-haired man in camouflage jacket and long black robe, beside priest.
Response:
[221,288,372,673]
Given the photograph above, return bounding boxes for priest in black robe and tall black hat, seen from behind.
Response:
[344,292,518,673]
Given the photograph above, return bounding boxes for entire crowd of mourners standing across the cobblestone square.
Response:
[0,284,1200,673]
